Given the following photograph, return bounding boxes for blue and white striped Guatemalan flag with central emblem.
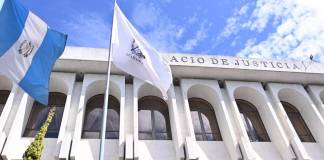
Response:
[0,0,67,105]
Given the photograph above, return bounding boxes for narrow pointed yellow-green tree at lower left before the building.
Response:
[23,107,56,160]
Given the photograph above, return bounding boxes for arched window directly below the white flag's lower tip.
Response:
[138,96,172,140]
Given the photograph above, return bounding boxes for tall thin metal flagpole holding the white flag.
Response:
[99,0,116,160]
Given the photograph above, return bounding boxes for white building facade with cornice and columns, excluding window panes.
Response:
[0,47,324,160]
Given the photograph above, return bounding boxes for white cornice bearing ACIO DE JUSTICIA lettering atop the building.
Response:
[54,47,324,84]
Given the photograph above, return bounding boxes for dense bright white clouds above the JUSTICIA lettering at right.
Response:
[219,0,324,62]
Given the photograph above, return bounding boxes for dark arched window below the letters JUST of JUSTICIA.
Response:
[236,100,270,142]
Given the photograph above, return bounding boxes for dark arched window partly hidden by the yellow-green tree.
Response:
[23,92,66,138]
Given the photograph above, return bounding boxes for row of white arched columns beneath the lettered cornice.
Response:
[0,73,324,159]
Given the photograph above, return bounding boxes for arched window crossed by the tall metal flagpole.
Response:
[82,94,120,139]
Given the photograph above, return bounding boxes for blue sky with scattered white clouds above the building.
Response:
[8,0,324,62]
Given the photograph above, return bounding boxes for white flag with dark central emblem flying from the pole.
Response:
[111,4,172,97]
